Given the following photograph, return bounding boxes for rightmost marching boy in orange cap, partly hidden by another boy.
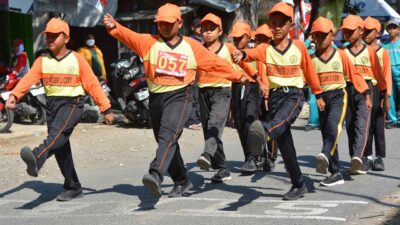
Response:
[363,17,392,171]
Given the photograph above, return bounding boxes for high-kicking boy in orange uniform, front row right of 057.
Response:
[234,2,325,200]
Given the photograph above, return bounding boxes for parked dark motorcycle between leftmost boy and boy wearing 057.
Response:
[111,53,150,126]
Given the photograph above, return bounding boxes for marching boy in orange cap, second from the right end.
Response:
[341,15,388,175]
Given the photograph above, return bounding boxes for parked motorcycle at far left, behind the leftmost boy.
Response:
[0,76,46,132]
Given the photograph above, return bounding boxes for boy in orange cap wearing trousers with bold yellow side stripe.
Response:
[311,17,371,186]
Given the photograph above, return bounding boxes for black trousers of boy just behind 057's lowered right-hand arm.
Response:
[199,87,231,169]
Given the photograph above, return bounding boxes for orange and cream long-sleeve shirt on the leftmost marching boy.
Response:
[11,51,111,112]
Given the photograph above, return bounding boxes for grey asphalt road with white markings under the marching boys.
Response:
[0,120,400,225]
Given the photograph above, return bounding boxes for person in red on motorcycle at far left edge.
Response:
[7,39,30,89]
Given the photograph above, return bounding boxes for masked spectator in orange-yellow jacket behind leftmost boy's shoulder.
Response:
[78,34,107,80]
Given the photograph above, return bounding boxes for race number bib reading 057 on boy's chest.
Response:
[156,51,188,77]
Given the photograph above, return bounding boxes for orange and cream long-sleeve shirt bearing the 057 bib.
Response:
[109,23,242,93]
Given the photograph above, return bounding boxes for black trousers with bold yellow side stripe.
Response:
[319,89,347,174]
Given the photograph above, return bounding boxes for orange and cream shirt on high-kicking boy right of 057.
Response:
[244,39,323,95]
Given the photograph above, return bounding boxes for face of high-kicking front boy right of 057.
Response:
[269,13,292,40]
